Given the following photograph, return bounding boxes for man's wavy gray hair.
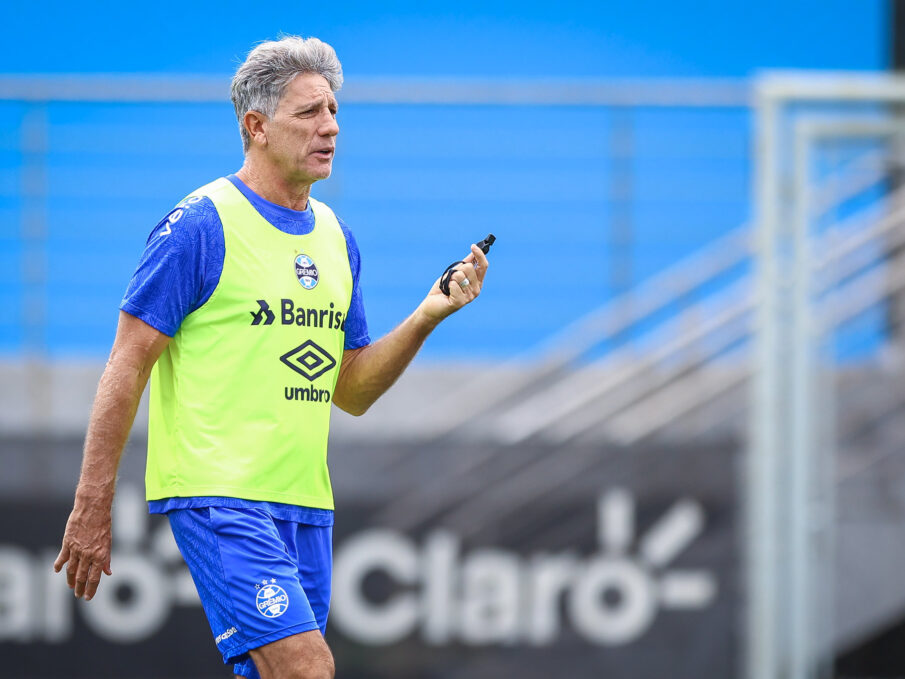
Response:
[230,35,343,152]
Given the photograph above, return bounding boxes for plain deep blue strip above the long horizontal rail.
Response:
[0,0,888,77]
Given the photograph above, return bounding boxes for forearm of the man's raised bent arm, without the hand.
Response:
[334,307,440,415]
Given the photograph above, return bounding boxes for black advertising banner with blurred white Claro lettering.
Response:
[0,438,740,679]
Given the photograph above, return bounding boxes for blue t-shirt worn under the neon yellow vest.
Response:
[120,174,371,526]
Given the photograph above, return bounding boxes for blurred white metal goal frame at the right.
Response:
[744,72,905,679]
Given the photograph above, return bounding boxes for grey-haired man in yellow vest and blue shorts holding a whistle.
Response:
[54,37,488,679]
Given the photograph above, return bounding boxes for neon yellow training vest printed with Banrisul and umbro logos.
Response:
[145,178,352,509]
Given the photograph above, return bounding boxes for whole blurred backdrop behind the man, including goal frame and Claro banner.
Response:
[0,0,905,679]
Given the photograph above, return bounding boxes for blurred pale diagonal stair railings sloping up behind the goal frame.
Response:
[415,145,898,444]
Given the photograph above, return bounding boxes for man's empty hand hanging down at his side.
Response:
[53,494,113,601]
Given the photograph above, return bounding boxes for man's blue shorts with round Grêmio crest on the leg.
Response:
[167,507,333,679]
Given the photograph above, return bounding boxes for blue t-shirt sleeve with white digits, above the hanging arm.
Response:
[120,198,226,337]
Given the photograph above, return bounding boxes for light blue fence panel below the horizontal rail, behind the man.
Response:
[0,87,751,358]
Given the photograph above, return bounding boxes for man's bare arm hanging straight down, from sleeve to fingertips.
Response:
[53,311,170,600]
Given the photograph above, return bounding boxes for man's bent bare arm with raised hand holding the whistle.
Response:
[333,245,488,415]
